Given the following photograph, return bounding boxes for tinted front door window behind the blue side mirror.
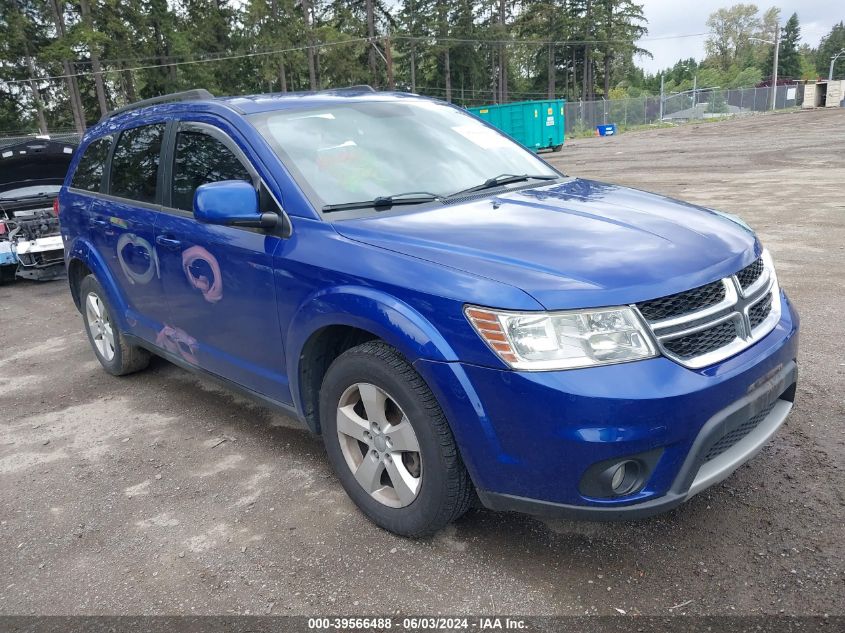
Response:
[171,132,252,211]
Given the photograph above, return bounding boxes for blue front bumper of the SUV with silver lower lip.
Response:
[416,295,798,520]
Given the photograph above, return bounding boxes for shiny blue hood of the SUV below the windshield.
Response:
[334,179,762,310]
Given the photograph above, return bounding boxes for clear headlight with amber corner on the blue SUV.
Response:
[464,306,657,370]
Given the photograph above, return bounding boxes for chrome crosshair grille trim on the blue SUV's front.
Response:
[631,251,781,369]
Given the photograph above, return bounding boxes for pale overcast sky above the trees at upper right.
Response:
[637,0,845,73]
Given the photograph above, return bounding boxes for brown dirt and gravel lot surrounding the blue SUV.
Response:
[0,109,845,615]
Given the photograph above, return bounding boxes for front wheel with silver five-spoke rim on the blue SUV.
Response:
[320,341,473,537]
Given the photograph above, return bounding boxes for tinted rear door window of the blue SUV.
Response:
[111,123,164,202]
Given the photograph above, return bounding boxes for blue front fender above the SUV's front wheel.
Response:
[274,217,540,420]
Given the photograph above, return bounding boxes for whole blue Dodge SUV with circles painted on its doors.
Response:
[59,88,798,536]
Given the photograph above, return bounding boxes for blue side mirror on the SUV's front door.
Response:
[194,180,281,229]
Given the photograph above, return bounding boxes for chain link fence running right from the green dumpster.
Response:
[565,84,804,136]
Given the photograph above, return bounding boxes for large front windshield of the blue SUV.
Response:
[250,100,559,208]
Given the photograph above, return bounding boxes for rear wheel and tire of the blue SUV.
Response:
[79,275,150,376]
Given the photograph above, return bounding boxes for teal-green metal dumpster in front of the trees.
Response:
[469,99,566,152]
